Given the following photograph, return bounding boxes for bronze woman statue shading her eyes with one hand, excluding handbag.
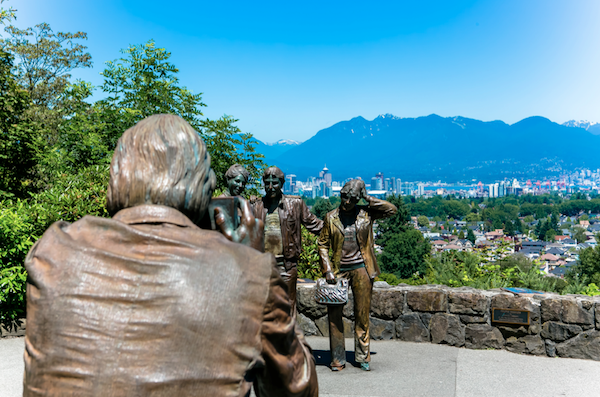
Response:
[318,179,398,371]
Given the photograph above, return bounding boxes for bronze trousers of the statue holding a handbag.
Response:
[327,266,373,367]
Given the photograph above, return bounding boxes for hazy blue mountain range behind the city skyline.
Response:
[251,114,600,182]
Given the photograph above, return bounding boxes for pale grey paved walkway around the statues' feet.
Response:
[0,337,600,397]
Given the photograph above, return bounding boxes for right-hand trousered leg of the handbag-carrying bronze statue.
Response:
[351,267,373,363]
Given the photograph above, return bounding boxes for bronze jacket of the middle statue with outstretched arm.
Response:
[252,195,323,262]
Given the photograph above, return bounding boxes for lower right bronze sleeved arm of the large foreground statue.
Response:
[254,258,319,397]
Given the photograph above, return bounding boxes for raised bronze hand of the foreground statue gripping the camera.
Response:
[215,197,265,251]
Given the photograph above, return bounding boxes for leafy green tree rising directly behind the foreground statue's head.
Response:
[98,40,264,193]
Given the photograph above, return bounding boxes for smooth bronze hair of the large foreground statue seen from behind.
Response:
[106,114,215,222]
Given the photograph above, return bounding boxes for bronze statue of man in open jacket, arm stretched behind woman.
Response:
[253,167,323,308]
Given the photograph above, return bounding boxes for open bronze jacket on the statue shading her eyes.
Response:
[318,196,398,278]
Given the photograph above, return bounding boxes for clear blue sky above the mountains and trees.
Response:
[2,0,600,142]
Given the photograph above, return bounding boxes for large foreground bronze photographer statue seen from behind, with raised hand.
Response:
[23,115,318,397]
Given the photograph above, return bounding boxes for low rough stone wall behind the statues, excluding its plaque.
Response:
[298,281,600,361]
